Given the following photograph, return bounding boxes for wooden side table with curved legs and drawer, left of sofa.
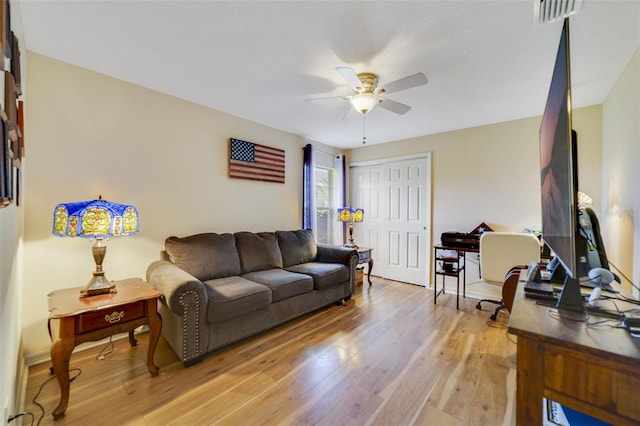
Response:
[48,278,162,420]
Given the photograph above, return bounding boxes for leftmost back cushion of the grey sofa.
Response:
[164,233,240,281]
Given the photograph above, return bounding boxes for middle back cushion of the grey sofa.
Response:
[234,232,282,274]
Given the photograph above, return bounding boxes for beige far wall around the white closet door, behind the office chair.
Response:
[348,106,602,256]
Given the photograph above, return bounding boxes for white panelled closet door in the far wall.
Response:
[350,155,431,286]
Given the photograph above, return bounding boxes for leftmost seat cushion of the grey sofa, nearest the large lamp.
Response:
[204,276,272,323]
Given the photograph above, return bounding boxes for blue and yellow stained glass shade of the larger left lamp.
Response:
[53,198,138,239]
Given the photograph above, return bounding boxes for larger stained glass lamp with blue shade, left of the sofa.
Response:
[53,196,138,298]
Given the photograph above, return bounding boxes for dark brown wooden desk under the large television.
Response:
[509,278,640,425]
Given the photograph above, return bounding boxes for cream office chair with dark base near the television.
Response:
[476,232,540,321]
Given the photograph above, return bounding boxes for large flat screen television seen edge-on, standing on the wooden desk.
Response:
[540,18,584,311]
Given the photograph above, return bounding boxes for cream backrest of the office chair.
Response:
[480,232,541,285]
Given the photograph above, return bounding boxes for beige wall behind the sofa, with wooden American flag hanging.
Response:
[23,53,305,356]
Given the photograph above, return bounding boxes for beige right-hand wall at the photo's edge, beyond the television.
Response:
[601,49,640,295]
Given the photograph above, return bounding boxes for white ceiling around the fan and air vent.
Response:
[12,0,640,148]
